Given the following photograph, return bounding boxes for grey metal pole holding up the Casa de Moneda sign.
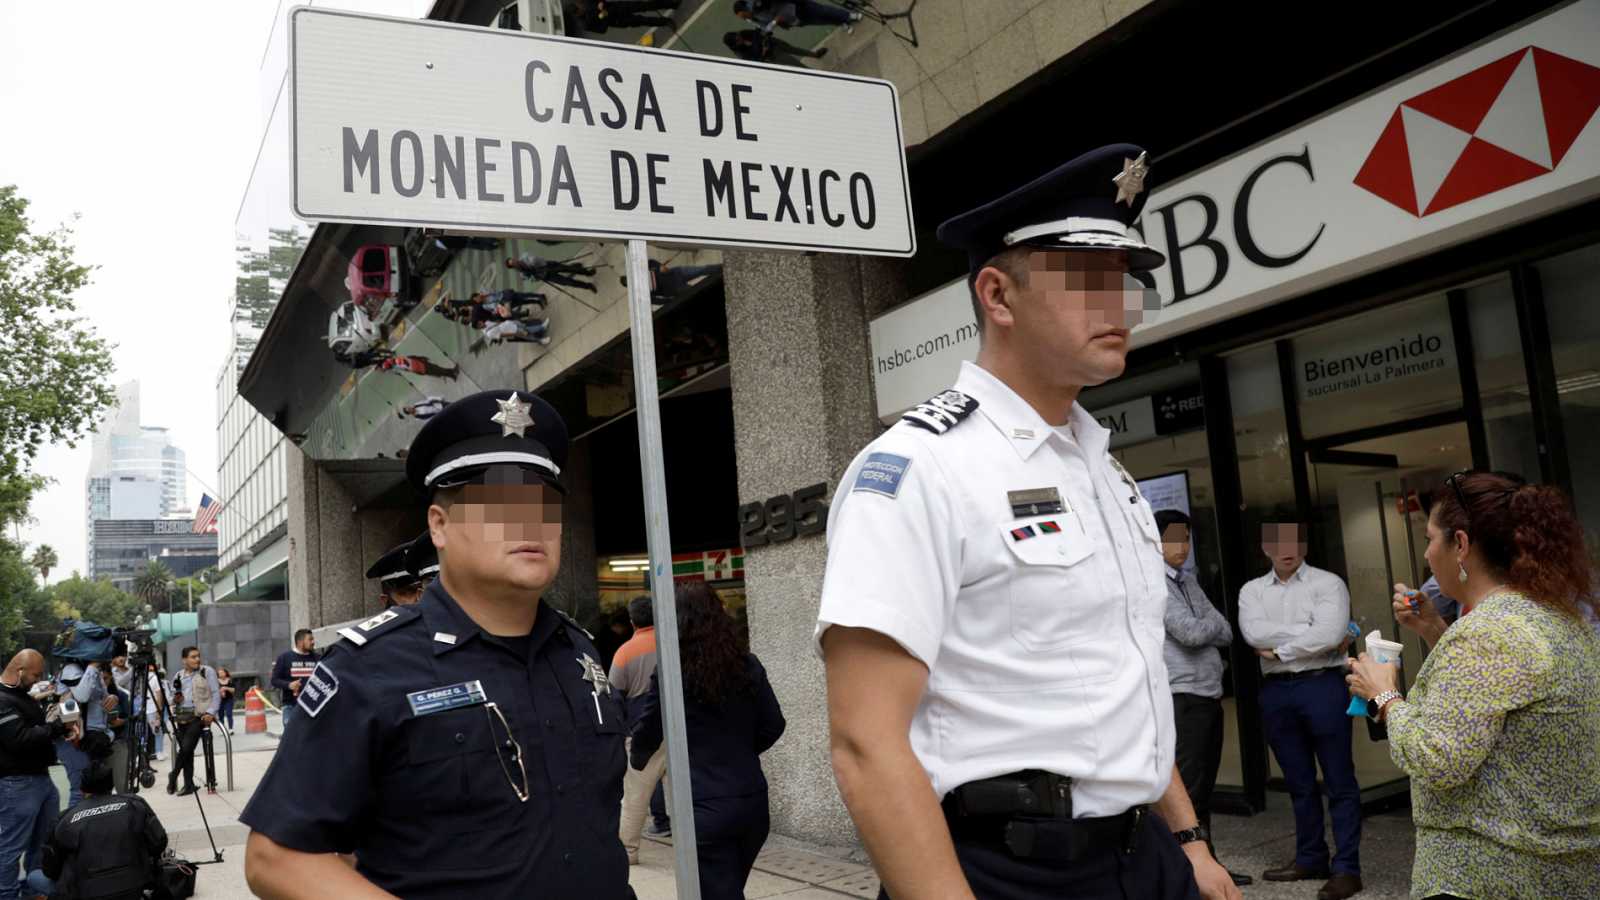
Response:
[627,240,699,900]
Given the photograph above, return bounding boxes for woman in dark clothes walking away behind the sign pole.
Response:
[629,581,786,900]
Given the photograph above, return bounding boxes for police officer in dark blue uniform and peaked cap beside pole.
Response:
[240,391,632,900]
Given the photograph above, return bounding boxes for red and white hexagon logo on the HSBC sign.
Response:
[1355,46,1600,218]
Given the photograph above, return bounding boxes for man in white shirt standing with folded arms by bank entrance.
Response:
[1238,522,1362,900]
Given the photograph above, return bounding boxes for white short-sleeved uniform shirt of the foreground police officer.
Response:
[816,364,1174,817]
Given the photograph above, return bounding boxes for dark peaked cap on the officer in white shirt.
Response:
[939,144,1166,272]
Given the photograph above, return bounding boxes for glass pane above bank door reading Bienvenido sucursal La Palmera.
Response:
[1293,295,1461,439]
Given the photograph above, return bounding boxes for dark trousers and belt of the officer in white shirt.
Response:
[878,815,1200,900]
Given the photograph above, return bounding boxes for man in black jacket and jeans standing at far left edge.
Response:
[0,650,83,900]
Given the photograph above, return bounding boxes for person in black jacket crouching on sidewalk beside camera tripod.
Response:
[27,746,166,900]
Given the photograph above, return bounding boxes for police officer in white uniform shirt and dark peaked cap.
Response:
[818,144,1238,900]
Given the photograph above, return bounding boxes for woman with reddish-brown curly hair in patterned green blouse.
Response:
[1349,472,1600,900]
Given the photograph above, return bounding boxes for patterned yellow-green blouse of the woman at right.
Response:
[1387,591,1600,900]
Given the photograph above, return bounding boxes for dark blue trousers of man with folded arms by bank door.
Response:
[1261,669,1362,874]
